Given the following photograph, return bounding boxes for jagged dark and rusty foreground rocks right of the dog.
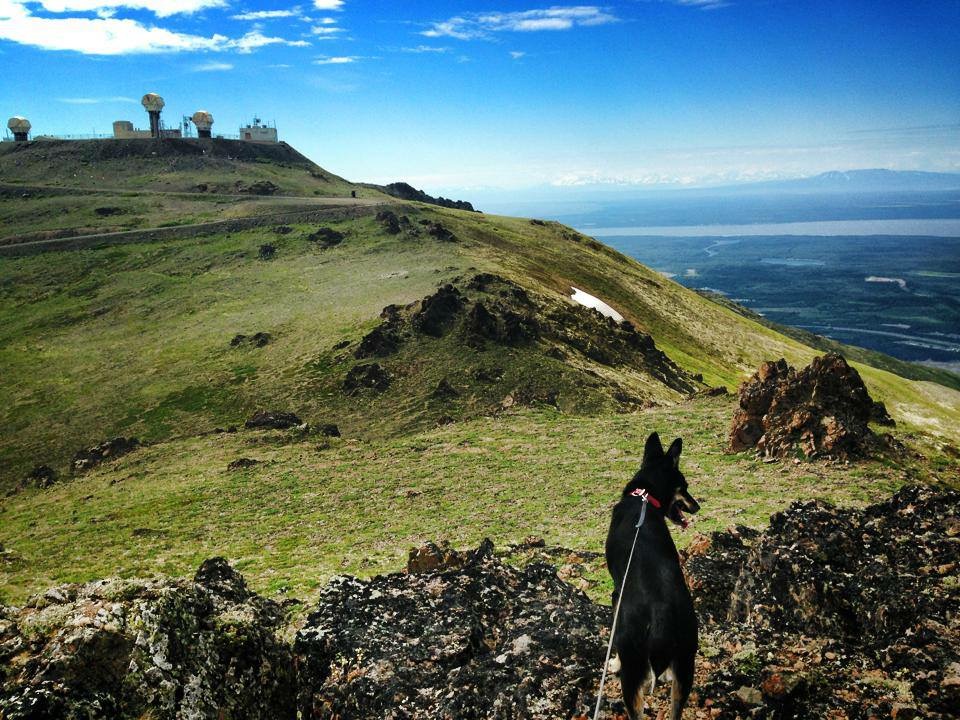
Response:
[686,487,960,720]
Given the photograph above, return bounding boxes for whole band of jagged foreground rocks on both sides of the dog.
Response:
[0,487,960,720]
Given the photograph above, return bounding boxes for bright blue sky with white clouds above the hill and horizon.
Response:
[0,0,960,193]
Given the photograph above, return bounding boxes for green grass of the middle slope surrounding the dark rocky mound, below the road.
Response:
[0,204,960,487]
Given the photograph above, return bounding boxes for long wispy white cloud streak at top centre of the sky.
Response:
[420,5,617,40]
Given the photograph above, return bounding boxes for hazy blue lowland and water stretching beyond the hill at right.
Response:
[488,192,960,372]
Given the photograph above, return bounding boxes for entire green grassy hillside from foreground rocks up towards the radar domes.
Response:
[0,143,960,600]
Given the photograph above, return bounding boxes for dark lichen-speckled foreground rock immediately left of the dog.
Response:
[294,543,609,720]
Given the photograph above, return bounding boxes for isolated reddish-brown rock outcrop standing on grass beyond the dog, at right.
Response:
[730,353,893,458]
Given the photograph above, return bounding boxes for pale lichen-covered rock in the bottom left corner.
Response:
[0,558,296,720]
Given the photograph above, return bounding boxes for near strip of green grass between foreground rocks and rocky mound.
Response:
[0,398,956,602]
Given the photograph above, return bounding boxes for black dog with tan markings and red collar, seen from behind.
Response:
[606,433,700,720]
